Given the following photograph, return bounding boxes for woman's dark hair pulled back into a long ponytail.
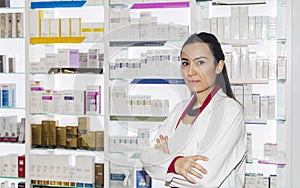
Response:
[182,32,236,100]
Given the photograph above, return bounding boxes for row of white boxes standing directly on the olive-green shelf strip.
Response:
[111,87,170,117]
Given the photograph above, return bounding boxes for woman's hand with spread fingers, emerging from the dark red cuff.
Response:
[174,155,208,184]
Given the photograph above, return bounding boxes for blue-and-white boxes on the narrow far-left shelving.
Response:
[0,83,16,108]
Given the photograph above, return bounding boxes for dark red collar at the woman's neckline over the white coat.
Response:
[175,85,221,129]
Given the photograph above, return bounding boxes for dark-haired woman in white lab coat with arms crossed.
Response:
[141,33,246,188]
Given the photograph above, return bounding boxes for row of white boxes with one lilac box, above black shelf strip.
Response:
[29,49,104,73]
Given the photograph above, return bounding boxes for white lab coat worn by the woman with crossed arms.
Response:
[141,89,246,188]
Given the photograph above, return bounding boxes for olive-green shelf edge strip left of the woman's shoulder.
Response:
[109,115,167,122]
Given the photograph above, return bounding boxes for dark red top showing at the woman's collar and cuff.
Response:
[167,85,221,173]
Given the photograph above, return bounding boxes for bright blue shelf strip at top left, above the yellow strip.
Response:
[30,0,86,9]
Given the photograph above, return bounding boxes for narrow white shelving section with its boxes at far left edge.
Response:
[0,0,26,187]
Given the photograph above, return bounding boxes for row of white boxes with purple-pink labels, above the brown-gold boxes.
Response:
[29,81,102,114]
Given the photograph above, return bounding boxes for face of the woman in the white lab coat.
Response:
[181,42,217,93]
